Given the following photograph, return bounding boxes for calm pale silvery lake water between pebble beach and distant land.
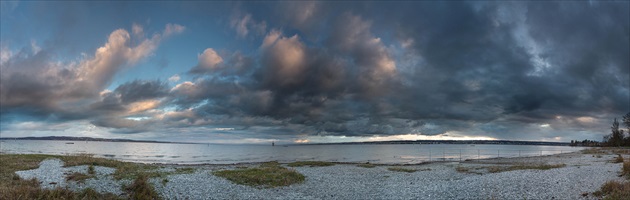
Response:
[0,140,584,164]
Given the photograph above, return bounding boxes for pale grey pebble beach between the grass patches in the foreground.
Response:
[16,152,623,199]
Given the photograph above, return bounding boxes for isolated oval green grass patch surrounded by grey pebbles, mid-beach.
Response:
[213,162,305,188]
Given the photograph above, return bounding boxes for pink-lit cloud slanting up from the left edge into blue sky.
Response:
[0,23,185,118]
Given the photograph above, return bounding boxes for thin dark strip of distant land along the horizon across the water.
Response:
[0,136,570,146]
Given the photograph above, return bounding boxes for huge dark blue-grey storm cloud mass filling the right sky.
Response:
[173,2,629,137]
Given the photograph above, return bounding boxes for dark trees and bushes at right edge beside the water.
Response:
[570,112,630,147]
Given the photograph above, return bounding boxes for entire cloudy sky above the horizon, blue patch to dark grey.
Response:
[0,1,630,143]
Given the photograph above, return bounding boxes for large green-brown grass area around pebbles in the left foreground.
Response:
[0,154,195,199]
